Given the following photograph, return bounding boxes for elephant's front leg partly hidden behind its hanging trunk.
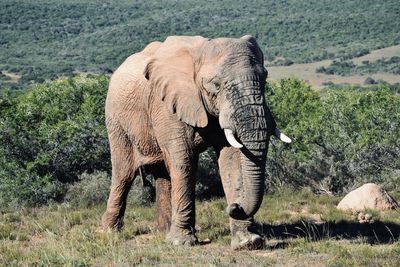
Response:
[217,147,264,250]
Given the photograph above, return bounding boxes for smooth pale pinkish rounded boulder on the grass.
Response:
[337,183,400,211]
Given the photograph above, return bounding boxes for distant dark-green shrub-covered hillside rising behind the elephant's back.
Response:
[0,0,400,87]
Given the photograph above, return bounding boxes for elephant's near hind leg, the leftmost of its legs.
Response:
[102,131,138,230]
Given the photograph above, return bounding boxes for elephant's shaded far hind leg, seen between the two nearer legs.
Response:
[150,165,172,232]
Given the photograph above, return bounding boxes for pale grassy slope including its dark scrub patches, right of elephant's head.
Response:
[268,45,400,88]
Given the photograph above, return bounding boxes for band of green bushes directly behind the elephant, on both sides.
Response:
[0,76,400,209]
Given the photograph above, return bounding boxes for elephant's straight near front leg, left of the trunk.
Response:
[166,153,198,246]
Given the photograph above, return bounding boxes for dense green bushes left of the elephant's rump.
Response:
[0,76,111,209]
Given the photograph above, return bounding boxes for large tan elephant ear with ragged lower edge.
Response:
[144,43,208,127]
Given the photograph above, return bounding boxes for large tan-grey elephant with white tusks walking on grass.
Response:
[102,35,291,249]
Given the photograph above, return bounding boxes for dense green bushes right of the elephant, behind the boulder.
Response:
[267,79,400,193]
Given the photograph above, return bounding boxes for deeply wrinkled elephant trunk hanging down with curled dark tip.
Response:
[227,78,268,220]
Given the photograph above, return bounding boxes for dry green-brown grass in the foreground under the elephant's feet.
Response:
[0,190,400,266]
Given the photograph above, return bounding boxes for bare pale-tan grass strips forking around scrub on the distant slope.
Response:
[267,45,400,88]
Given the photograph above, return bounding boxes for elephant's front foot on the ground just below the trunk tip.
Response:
[231,219,264,250]
